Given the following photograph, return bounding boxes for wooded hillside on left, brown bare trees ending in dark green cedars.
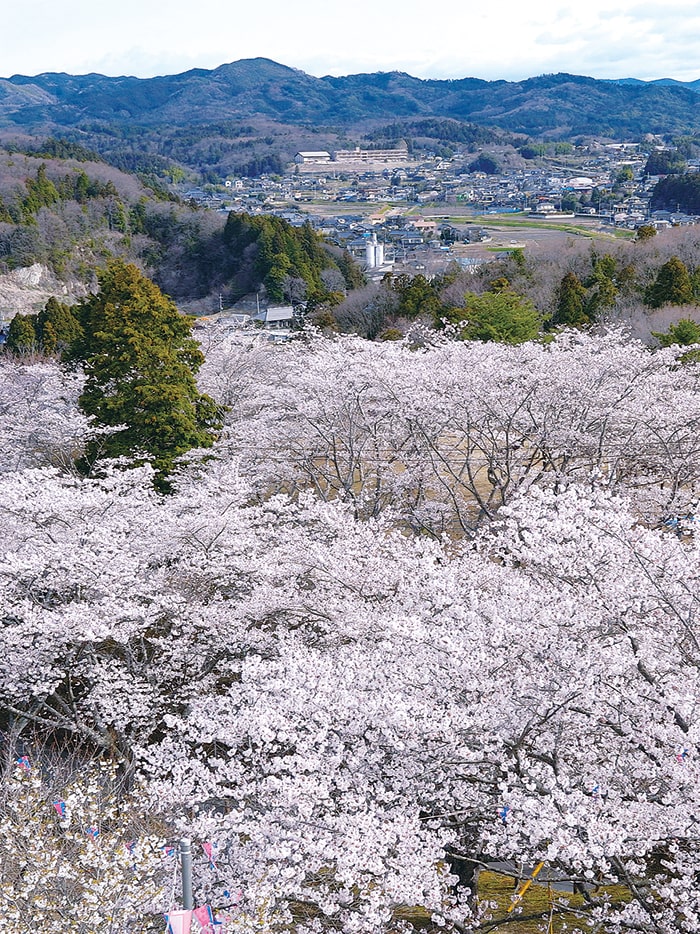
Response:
[0,146,361,307]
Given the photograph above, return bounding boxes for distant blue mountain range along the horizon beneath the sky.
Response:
[0,58,700,139]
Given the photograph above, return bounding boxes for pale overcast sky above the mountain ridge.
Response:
[5,0,700,81]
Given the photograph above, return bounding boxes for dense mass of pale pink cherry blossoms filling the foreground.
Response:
[1,463,700,931]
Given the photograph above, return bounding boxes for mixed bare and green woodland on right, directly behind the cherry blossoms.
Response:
[324,226,700,343]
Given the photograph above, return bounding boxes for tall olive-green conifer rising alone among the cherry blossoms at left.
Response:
[73,260,221,491]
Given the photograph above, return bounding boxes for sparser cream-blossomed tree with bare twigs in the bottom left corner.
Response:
[0,755,167,934]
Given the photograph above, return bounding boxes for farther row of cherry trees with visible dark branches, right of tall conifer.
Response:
[198,332,700,535]
